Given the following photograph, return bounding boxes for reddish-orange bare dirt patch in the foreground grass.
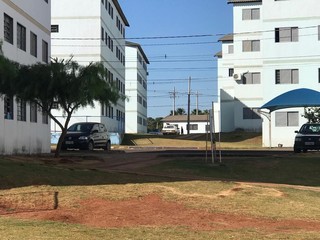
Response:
[4,194,320,232]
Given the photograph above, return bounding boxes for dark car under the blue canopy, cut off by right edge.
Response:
[293,123,320,153]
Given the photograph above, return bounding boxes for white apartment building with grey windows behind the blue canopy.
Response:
[218,0,320,147]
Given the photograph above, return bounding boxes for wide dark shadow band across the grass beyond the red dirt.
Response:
[0,151,320,189]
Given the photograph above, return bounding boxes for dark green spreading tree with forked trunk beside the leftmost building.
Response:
[0,56,125,157]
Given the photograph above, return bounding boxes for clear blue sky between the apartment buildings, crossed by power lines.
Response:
[119,0,233,118]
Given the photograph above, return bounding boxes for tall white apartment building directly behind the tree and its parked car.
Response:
[51,0,129,142]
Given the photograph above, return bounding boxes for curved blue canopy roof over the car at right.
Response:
[260,88,320,112]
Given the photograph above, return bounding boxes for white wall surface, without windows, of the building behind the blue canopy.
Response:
[218,0,320,147]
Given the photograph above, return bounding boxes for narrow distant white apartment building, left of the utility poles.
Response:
[125,41,149,133]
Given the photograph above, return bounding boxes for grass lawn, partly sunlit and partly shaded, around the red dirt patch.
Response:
[0,154,320,240]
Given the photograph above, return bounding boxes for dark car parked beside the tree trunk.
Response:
[62,122,111,151]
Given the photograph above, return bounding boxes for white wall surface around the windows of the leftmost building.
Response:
[0,0,51,154]
